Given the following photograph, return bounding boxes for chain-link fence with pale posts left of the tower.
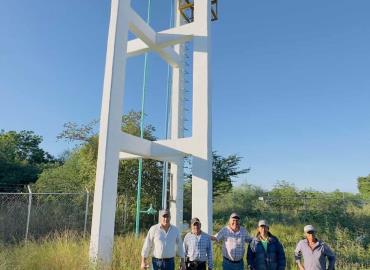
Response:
[0,189,91,244]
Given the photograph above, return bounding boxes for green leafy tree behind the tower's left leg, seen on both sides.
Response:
[35,112,162,232]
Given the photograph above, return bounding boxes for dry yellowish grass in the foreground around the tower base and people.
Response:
[0,228,370,270]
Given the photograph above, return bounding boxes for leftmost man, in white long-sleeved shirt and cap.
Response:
[141,210,185,270]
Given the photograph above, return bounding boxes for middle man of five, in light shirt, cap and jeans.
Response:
[212,213,252,270]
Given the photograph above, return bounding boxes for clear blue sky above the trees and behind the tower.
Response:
[0,0,370,192]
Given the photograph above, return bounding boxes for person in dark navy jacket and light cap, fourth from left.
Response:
[247,220,286,270]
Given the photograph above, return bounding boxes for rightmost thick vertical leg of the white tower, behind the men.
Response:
[192,0,213,233]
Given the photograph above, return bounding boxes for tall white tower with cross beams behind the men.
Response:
[90,0,217,264]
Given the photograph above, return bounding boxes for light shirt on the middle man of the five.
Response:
[216,226,252,261]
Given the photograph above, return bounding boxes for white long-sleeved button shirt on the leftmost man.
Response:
[141,224,184,259]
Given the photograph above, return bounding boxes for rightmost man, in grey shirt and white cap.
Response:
[295,225,335,270]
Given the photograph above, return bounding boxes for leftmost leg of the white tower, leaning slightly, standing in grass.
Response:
[89,0,131,264]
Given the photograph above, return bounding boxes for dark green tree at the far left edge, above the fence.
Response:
[0,130,57,191]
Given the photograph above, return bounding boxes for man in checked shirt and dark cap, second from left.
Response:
[184,218,213,270]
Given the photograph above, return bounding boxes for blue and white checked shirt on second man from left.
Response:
[184,232,213,268]
